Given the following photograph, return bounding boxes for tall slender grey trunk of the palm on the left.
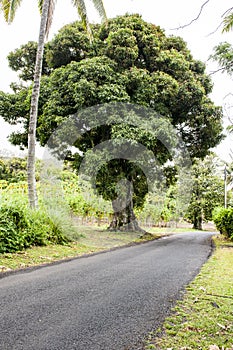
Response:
[27,0,51,208]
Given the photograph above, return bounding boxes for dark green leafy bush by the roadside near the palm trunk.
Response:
[0,203,70,253]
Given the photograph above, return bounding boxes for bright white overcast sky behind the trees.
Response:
[0,0,233,160]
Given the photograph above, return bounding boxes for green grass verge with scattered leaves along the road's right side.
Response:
[145,236,233,350]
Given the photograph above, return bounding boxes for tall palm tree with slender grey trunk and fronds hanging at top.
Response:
[0,0,106,208]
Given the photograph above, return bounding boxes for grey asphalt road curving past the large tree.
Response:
[0,233,215,350]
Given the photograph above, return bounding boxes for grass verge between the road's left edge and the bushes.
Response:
[0,226,159,273]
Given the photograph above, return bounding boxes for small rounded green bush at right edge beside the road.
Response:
[213,208,233,240]
